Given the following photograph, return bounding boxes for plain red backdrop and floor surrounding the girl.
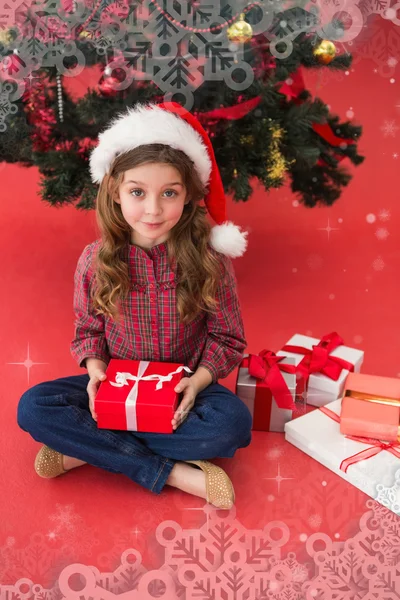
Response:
[0,9,400,584]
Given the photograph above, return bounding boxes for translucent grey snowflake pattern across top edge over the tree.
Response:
[0,0,374,123]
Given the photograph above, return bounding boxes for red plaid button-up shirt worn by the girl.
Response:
[70,240,247,382]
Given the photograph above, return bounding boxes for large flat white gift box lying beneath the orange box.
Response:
[285,400,400,510]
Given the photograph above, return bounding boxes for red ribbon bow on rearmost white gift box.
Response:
[282,331,354,383]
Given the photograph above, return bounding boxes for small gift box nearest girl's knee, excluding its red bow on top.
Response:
[236,354,301,432]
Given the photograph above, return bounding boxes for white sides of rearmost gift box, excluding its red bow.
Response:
[276,333,364,406]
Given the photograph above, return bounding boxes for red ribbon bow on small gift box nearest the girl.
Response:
[244,350,296,410]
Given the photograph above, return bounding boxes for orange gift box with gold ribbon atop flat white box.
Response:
[340,373,400,442]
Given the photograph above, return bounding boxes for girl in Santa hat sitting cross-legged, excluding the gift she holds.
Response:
[18,102,252,509]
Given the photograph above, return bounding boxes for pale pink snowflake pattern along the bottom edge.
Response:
[0,502,400,600]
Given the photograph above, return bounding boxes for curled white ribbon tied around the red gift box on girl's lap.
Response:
[109,360,193,431]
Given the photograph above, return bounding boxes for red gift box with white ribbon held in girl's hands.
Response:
[94,358,192,433]
